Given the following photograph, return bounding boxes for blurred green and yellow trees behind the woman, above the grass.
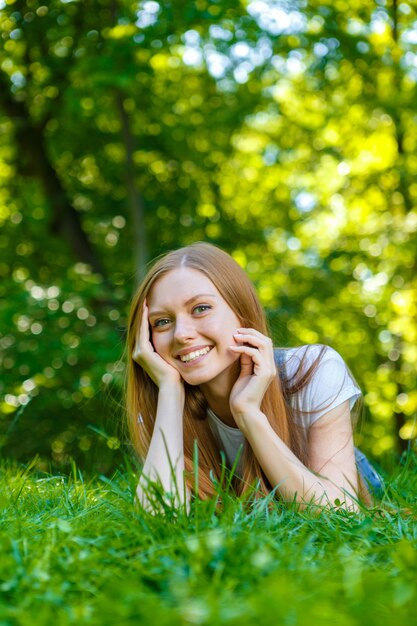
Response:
[0,0,417,473]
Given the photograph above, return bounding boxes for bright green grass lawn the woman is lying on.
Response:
[0,455,417,626]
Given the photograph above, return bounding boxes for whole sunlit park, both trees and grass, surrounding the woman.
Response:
[0,0,417,626]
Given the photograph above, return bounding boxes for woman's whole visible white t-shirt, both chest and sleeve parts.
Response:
[207,345,361,475]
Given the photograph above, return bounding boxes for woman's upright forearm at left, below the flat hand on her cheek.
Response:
[137,385,187,504]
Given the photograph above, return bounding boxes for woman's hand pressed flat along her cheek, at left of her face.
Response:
[132,301,182,388]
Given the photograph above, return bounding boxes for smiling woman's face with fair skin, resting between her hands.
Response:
[147,267,240,385]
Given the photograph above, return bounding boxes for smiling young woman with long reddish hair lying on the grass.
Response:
[127,243,380,510]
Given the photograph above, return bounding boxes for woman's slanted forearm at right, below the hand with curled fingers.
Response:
[241,412,357,510]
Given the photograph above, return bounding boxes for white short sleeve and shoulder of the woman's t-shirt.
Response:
[286,345,361,428]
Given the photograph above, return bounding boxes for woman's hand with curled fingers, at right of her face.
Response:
[229,328,277,426]
